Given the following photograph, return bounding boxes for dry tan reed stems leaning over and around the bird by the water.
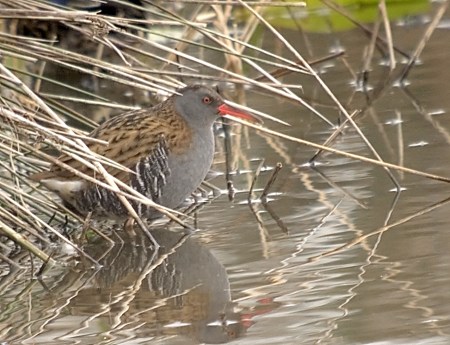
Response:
[0,0,450,263]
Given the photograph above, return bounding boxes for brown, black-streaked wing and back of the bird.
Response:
[30,109,191,183]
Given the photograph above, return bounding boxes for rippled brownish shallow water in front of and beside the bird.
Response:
[0,2,450,345]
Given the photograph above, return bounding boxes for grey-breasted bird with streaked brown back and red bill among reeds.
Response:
[29,84,260,219]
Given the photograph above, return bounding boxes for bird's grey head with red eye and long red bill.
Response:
[174,85,256,128]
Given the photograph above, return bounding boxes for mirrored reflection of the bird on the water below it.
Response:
[35,229,249,344]
